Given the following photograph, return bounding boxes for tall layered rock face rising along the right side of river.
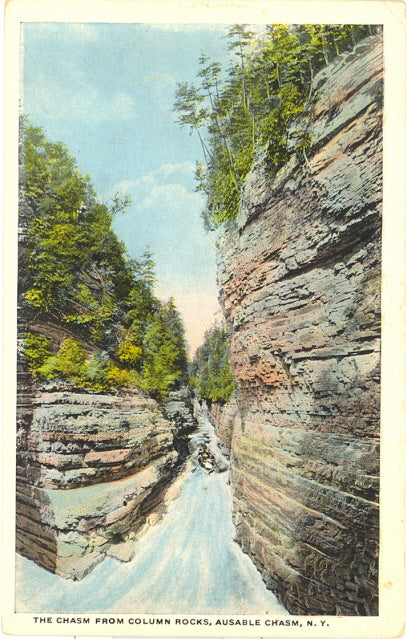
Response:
[215,36,383,615]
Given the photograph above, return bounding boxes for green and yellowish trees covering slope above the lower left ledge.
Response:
[22,123,187,399]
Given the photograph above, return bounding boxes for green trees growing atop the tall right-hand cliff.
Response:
[174,24,378,228]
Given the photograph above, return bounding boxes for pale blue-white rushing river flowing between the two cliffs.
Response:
[16,402,288,614]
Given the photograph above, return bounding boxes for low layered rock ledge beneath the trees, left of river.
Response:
[17,390,195,579]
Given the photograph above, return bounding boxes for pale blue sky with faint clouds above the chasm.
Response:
[23,23,233,350]
